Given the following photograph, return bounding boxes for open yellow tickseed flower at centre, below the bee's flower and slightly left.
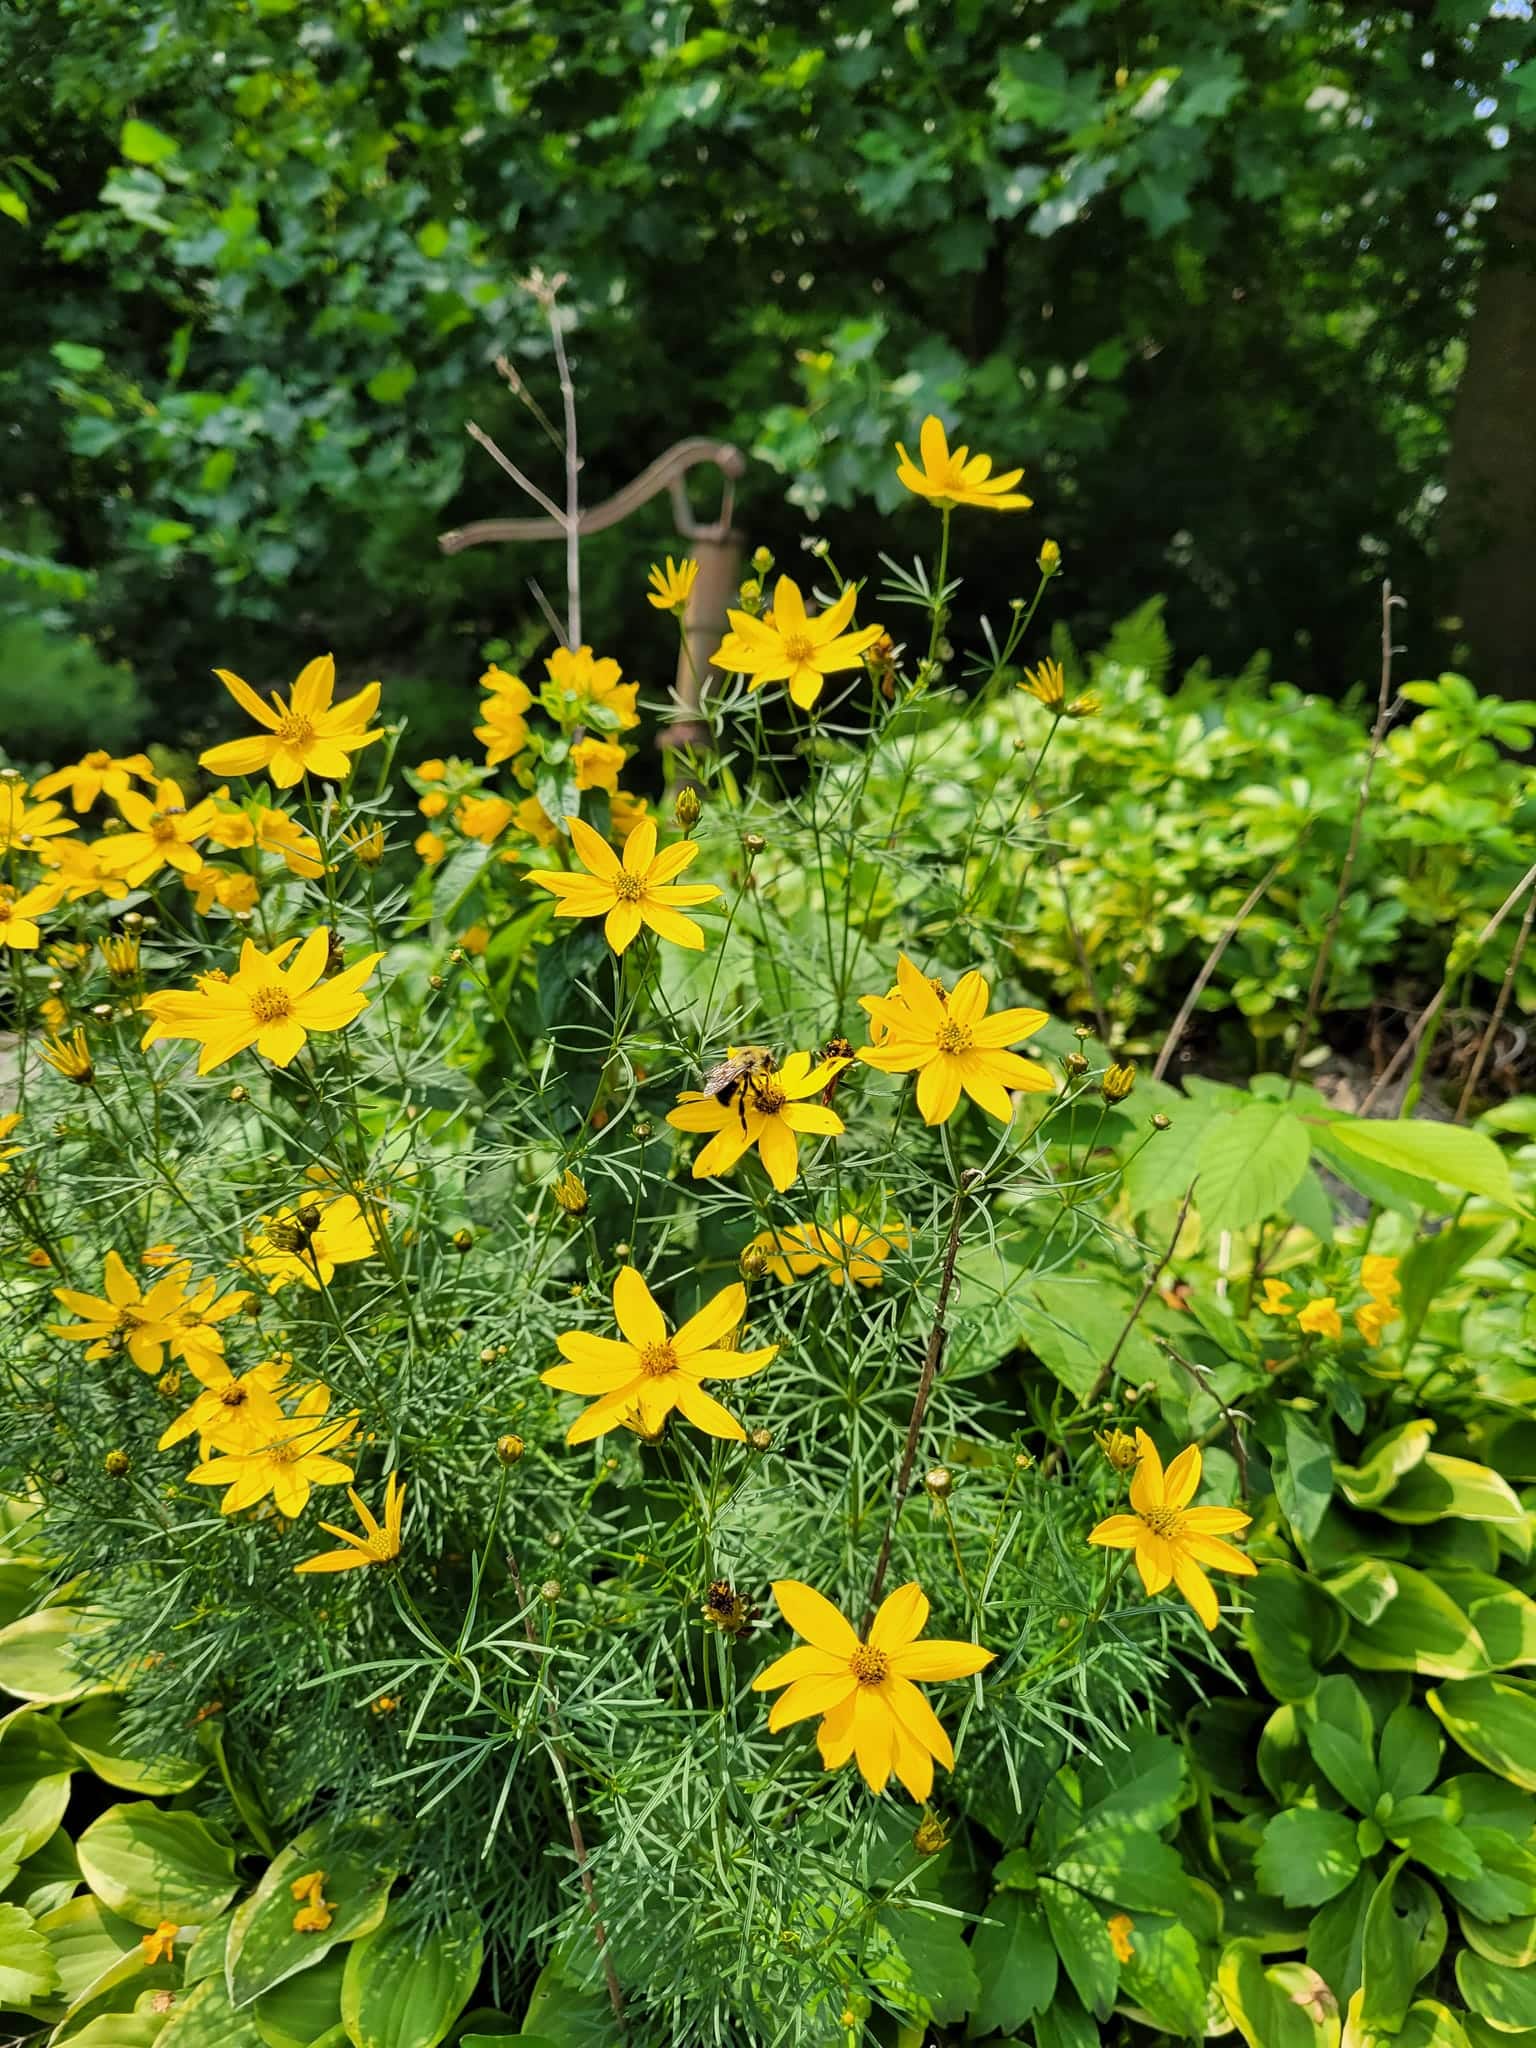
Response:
[541,1266,778,1444]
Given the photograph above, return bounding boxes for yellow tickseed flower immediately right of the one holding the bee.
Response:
[858,952,1055,1124]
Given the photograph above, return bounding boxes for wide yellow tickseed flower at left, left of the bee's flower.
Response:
[141,926,383,1073]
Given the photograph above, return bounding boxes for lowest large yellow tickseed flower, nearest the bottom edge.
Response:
[752,1579,993,1802]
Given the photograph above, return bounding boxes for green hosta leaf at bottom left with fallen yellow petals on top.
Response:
[225,1821,397,2009]
